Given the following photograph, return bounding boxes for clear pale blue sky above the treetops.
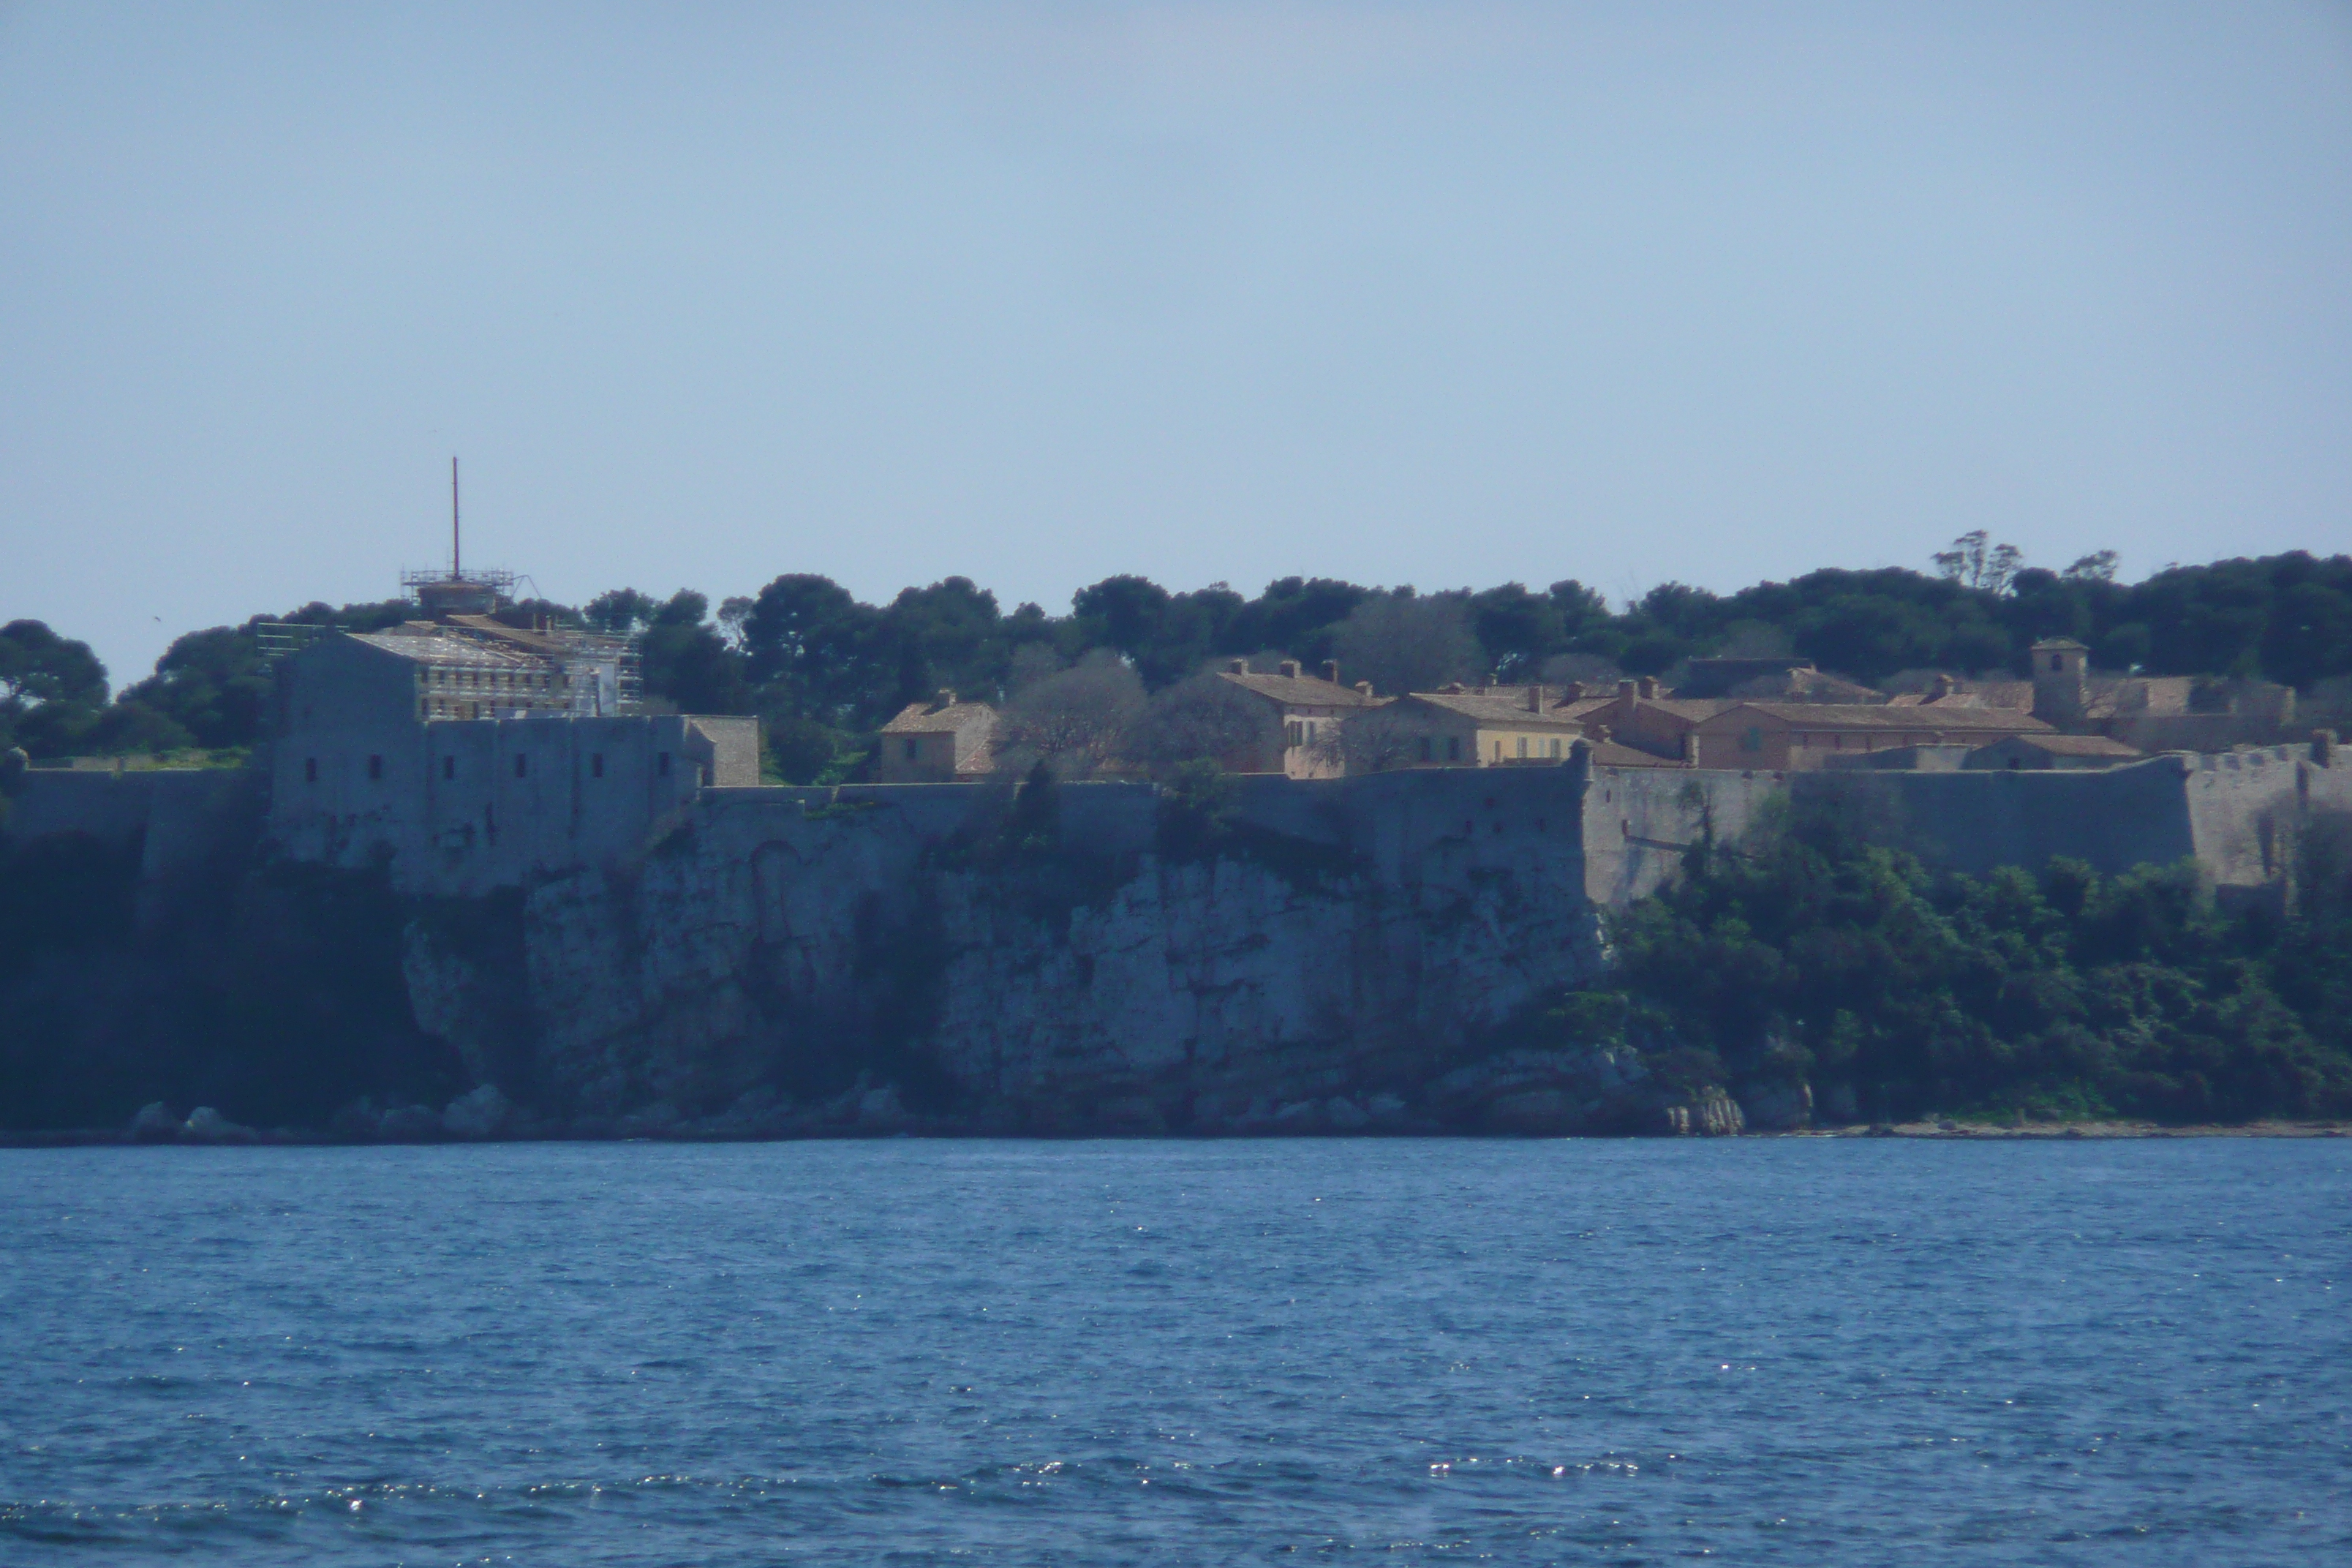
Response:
[0,0,2352,682]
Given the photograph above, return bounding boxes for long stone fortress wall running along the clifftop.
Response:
[7,733,2352,908]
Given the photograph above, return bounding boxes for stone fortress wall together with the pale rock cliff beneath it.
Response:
[10,738,2352,1131]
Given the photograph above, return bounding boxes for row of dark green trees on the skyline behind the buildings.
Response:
[13,534,2352,780]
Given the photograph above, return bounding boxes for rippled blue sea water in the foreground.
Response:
[0,1140,2352,1566]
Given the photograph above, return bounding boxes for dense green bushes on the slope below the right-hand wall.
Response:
[1561,811,2352,1121]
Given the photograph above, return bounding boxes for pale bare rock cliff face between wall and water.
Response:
[407,811,1627,1131]
